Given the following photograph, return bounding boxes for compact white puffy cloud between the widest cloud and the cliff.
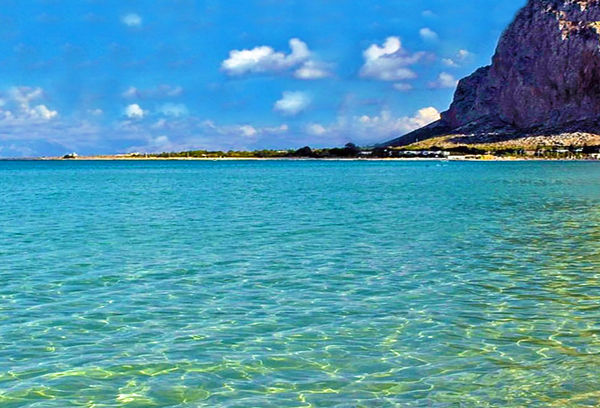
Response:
[360,37,425,81]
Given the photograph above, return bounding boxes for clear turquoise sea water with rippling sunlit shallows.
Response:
[0,162,600,408]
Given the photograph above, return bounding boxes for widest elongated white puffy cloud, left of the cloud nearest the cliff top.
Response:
[221,38,331,79]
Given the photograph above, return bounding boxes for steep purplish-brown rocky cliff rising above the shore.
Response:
[388,0,600,145]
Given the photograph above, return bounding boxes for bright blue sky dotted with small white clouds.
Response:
[0,0,525,157]
